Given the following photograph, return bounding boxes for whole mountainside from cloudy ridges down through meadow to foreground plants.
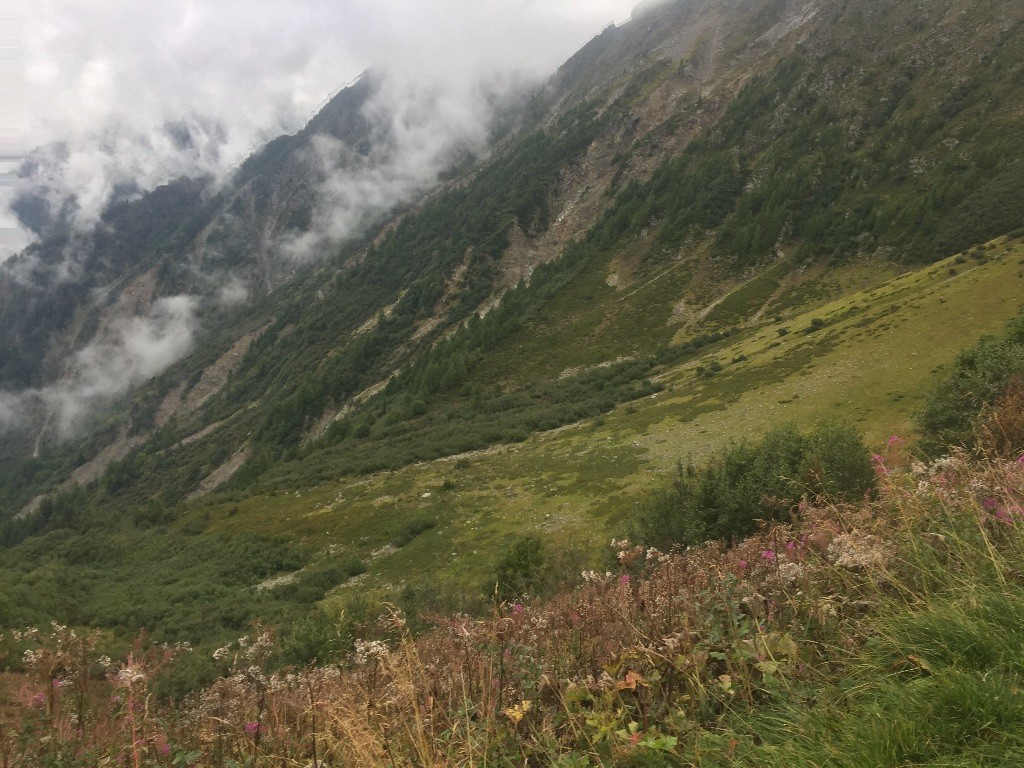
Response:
[0,0,1024,663]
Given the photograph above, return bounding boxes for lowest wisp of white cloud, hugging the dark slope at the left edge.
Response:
[0,296,198,437]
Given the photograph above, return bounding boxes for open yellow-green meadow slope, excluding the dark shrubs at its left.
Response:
[180,237,1024,610]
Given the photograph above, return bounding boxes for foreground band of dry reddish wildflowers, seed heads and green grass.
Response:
[6,441,1024,768]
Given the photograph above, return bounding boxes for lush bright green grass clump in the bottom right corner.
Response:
[716,505,1024,768]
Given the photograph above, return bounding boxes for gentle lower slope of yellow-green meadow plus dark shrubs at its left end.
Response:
[0,234,1024,641]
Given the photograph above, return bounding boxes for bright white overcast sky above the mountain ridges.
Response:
[0,0,635,260]
